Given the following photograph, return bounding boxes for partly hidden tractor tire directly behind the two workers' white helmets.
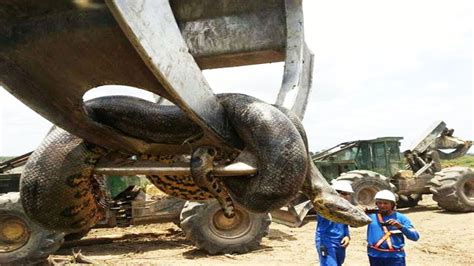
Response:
[336,170,395,207]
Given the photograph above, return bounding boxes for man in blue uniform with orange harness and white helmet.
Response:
[367,190,420,266]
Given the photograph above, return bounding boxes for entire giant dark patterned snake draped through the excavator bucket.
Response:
[20,94,368,232]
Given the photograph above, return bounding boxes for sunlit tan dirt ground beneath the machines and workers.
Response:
[51,196,474,265]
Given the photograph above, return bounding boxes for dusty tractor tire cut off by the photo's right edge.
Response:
[429,166,474,212]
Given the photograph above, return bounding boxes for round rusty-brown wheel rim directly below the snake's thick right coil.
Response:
[209,208,252,239]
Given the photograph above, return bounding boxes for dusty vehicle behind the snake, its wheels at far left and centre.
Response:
[0,153,274,262]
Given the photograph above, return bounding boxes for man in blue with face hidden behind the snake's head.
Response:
[316,181,354,266]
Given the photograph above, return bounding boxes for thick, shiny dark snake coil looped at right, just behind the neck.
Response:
[219,94,309,212]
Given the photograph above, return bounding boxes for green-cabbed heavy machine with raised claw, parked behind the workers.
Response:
[312,121,474,212]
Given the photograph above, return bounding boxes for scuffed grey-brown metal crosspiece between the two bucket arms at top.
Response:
[170,0,286,69]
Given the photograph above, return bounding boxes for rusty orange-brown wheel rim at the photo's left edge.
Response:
[0,215,30,253]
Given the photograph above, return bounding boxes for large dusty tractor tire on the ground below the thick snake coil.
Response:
[181,200,271,255]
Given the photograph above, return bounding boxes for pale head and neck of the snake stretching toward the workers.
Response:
[302,163,371,227]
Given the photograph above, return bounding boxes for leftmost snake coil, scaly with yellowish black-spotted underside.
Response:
[20,127,104,232]
